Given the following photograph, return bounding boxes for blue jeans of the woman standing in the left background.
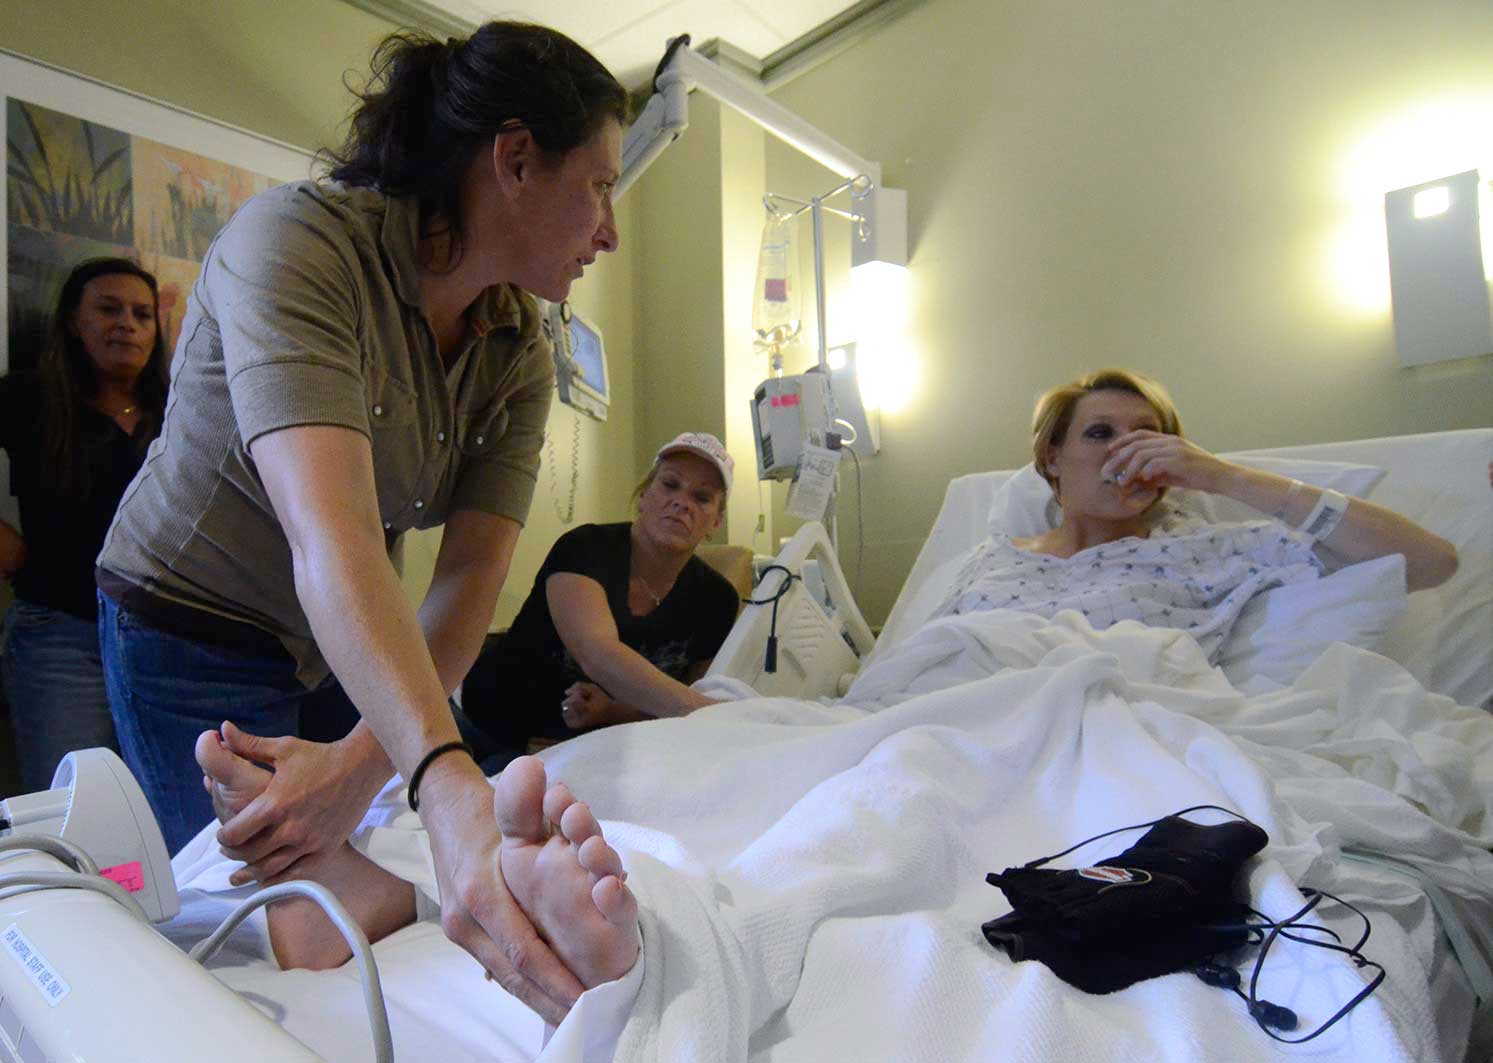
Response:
[0,599,119,796]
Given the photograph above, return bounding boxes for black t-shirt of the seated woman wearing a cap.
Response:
[461,523,739,745]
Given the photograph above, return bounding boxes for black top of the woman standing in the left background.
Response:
[0,373,149,620]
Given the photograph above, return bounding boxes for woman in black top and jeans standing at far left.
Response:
[0,258,166,791]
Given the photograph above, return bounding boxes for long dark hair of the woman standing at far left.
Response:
[36,258,169,497]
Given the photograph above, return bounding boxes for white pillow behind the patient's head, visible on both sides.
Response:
[990,454,1384,539]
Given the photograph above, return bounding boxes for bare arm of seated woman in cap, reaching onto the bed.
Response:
[545,572,715,717]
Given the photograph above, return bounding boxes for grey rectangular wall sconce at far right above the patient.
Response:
[1384,170,1493,366]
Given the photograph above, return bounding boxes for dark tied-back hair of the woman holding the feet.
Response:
[327,22,627,260]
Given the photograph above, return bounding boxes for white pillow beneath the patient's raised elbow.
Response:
[1218,554,1408,687]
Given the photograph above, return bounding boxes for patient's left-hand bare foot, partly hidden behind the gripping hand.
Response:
[196,723,415,970]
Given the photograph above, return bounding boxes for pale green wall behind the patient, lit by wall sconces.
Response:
[767,0,1493,623]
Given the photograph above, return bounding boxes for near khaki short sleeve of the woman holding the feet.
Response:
[202,187,369,446]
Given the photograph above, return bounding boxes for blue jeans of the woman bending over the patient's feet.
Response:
[99,594,358,855]
